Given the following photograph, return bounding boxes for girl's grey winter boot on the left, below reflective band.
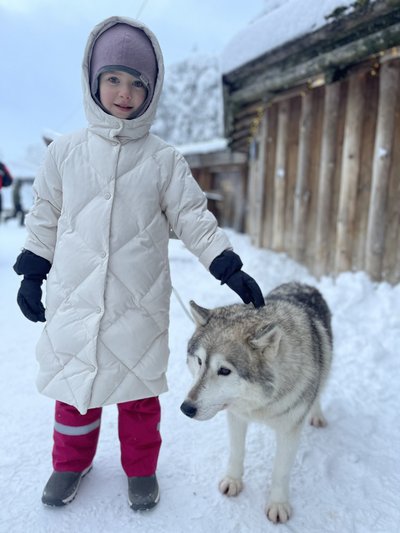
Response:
[42,465,92,507]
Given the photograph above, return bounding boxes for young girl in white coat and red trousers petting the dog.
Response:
[14,17,264,510]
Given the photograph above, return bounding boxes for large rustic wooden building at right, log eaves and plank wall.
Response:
[223,0,400,283]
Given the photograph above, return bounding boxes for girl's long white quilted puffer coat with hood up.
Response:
[25,17,231,414]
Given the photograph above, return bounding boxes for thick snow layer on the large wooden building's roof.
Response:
[220,0,354,74]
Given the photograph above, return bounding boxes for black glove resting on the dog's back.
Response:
[210,250,265,307]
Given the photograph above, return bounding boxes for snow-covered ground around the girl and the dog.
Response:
[0,222,400,533]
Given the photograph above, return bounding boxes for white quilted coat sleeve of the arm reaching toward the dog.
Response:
[161,152,232,269]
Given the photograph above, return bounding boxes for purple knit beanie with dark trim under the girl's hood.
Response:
[89,23,158,116]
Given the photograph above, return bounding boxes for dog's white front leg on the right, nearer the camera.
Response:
[265,427,301,523]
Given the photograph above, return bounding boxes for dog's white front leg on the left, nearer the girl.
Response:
[219,411,247,496]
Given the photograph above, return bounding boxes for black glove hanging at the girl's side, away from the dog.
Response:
[13,250,51,322]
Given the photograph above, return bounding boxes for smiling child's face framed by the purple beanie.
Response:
[99,70,147,118]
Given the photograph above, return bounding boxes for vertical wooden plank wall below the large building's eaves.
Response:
[246,56,400,283]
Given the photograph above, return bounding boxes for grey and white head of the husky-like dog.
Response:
[181,302,281,420]
